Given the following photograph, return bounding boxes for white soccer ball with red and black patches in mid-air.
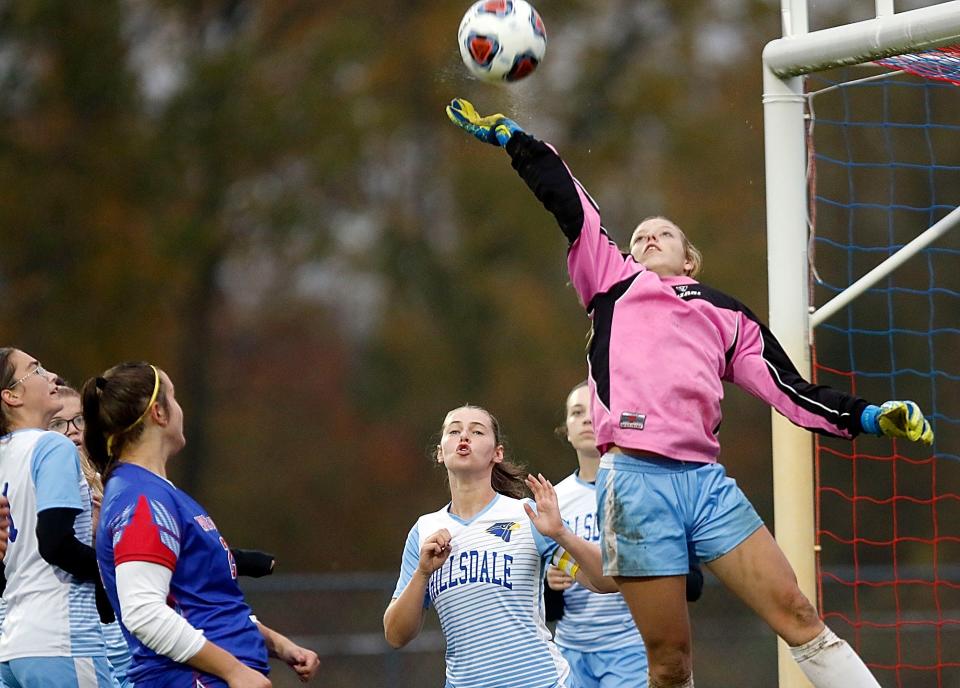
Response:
[457,0,547,82]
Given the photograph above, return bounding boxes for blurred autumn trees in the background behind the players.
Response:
[0,0,796,571]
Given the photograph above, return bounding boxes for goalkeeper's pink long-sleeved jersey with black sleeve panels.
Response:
[507,133,867,463]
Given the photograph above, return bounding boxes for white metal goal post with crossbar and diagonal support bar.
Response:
[763,0,960,688]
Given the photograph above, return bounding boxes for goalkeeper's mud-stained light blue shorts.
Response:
[597,454,763,577]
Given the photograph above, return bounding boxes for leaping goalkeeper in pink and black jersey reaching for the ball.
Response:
[447,99,933,688]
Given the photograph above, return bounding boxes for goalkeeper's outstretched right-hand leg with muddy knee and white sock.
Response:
[706,528,880,688]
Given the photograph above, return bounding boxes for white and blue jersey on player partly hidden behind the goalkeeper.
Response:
[554,473,643,652]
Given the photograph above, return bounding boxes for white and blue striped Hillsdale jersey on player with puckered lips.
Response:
[393,494,570,688]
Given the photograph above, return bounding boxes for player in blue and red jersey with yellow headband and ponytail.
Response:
[82,363,320,688]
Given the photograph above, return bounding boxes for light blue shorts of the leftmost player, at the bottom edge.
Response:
[0,657,117,688]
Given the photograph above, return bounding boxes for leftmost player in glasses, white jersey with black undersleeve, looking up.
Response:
[0,347,113,688]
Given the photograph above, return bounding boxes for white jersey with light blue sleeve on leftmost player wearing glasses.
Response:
[0,430,106,662]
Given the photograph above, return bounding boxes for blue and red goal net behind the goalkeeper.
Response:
[806,47,960,687]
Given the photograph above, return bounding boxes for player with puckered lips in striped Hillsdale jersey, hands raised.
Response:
[383,406,616,688]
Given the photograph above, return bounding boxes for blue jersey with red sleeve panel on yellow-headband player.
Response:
[96,464,269,688]
